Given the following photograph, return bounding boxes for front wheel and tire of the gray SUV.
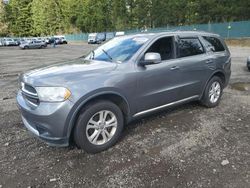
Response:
[74,100,124,153]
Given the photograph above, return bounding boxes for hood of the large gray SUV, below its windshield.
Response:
[21,58,117,86]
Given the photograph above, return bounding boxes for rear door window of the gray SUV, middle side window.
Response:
[178,38,204,57]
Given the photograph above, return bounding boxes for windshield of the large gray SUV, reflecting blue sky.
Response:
[86,37,148,62]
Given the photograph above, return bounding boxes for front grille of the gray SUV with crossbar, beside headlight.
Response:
[21,82,39,106]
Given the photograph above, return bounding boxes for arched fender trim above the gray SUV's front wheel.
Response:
[64,88,130,138]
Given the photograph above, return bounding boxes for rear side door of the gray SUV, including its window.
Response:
[173,36,214,99]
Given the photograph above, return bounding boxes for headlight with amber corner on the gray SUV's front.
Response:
[36,87,71,102]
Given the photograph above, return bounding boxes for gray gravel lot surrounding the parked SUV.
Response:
[0,44,250,188]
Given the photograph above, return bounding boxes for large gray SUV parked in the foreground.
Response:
[17,32,231,153]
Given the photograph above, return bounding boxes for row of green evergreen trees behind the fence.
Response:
[0,0,250,36]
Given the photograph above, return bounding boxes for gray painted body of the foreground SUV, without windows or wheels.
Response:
[17,32,231,146]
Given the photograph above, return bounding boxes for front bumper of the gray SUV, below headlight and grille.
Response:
[17,91,72,147]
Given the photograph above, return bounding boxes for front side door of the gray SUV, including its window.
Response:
[136,37,183,113]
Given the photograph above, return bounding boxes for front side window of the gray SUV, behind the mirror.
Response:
[143,37,174,61]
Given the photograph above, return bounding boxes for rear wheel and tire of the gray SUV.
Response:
[201,76,223,108]
